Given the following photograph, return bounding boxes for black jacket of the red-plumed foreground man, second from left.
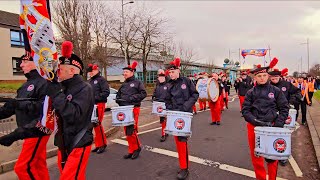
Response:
[52,75,94,148]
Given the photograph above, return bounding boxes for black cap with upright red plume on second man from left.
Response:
[59,41,84,74]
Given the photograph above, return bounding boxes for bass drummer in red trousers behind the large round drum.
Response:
[209,73,222,125]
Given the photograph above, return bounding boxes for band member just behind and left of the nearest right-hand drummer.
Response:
[238,71,253,112]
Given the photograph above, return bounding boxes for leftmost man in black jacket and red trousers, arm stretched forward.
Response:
[0,55,50,180]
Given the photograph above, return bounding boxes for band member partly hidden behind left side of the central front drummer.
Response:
[152,69,168,142]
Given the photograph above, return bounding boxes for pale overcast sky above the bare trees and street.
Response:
[0,0,320,74]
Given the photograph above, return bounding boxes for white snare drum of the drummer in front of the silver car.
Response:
[111,105,134,126]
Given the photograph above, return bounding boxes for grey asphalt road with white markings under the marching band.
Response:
[0,94,320,180]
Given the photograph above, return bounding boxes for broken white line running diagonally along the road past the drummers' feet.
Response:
[111,139,285,180]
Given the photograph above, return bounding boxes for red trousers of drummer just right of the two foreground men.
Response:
[94,103,107,147]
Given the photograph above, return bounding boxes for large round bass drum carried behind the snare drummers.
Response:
[196,78,219,102]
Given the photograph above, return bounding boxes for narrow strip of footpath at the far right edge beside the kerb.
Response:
[307,98,320,169]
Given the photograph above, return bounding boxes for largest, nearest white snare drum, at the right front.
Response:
[254,127,291,160]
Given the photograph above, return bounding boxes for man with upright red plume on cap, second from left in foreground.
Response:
[47,41,94,179]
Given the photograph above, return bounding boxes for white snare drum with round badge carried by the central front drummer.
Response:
[164,111,193,137]
